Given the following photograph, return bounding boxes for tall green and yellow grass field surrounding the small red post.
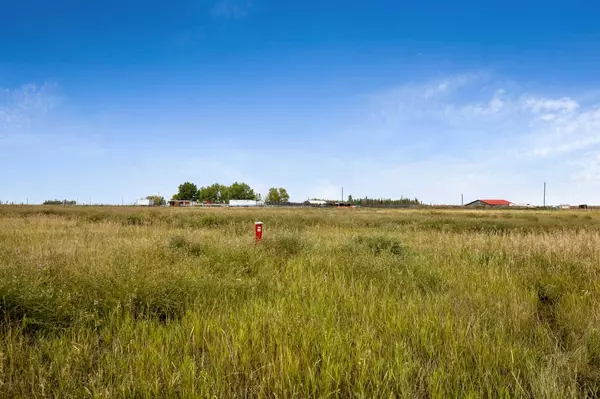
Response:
[0,206,600,398]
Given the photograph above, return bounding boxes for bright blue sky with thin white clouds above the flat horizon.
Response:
[0,0,600,204]
